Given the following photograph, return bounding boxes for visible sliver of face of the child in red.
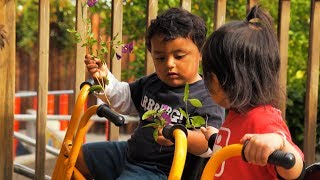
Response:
[208,74,230,109]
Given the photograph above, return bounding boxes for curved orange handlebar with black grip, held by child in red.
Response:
[201,144,296,180]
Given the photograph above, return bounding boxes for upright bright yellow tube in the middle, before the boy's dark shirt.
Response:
[168,129,188,180]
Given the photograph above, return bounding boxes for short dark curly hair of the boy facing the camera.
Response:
[146,8,207,51]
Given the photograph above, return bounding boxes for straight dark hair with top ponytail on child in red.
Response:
[202,6,280,112]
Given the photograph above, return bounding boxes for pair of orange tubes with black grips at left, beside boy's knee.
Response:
[52,82,124,180]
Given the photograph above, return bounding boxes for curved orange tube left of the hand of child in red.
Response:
[201,144,243,180]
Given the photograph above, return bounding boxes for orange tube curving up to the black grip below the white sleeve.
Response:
[66,105,99,179]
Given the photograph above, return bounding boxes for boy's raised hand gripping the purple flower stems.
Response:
[84,54,108,79]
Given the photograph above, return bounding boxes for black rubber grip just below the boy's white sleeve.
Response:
[97,104,125,126]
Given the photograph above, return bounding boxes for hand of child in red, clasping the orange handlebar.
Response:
[240,133,285,166]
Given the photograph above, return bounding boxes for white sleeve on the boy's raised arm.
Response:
[95,70,138,115]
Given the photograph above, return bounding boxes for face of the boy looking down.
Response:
[151,36,201,87]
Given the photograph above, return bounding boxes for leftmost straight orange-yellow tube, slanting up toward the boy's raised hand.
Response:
[52,84,90,180]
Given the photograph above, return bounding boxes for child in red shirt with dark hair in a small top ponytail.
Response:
[201,6,303,179]
